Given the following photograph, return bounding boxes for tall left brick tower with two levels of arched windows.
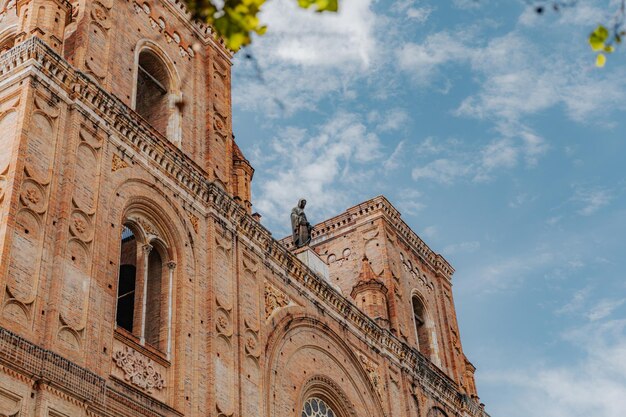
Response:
[0,0,254,416]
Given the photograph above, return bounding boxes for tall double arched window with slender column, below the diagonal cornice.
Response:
[115,218,176,357]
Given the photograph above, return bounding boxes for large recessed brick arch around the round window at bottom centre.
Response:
[265,309,384,417]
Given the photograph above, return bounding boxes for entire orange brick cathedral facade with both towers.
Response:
[0,0,488,417]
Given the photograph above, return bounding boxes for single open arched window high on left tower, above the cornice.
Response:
[134,48,181,144]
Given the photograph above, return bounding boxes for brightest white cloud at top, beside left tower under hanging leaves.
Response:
[233,0,381,116]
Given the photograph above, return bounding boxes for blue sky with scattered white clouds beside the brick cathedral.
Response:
[233,0,626,417]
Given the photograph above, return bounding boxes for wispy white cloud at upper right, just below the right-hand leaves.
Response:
[398,29,626,128]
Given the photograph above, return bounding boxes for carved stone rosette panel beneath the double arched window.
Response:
[113,347,165,394]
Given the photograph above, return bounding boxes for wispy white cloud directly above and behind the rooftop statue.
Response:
[255,113,382,229]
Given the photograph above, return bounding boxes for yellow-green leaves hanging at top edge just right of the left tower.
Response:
[185,0,339,51]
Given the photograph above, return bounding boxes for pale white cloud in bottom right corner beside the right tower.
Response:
[482,319,626,417]
